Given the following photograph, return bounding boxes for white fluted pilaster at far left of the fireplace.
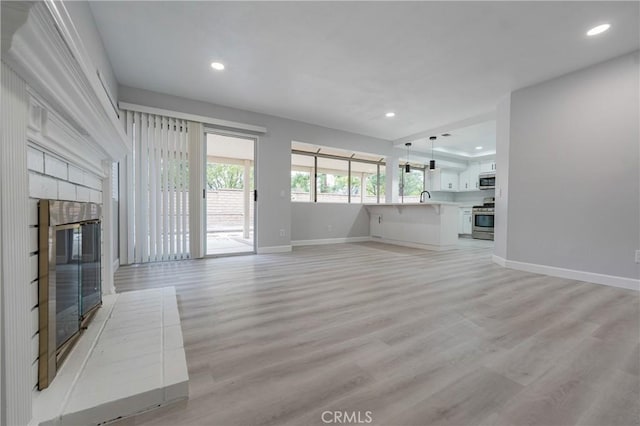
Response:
[0,62,34,425]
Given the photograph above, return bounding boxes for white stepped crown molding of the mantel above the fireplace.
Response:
[2,0,130,161]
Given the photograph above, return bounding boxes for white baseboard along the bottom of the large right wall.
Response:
[491,255,640,291]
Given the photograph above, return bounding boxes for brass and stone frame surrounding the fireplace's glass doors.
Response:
[38,200,102,390]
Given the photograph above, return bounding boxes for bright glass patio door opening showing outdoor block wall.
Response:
[205,133,256,256]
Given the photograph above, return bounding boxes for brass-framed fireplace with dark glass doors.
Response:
[38,200,102,390]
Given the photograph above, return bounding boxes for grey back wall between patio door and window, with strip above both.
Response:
[119,86,392,248]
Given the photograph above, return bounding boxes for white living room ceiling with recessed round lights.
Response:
[91,1,639,140]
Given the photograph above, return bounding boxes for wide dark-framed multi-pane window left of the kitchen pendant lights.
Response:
[291,142,385,203]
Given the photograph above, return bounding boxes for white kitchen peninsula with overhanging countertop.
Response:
[365,201,459,250]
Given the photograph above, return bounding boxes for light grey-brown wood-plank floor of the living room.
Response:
[116,243,640,426]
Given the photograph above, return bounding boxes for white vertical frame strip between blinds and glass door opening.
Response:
[187,121,205,259]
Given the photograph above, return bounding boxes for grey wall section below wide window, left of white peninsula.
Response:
[291,203,369,244]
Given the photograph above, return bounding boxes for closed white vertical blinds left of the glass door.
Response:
[126,111,189,263]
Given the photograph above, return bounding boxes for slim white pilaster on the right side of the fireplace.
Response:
[102,160,116,294]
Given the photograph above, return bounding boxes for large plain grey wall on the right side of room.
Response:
[508,51,640,279]
